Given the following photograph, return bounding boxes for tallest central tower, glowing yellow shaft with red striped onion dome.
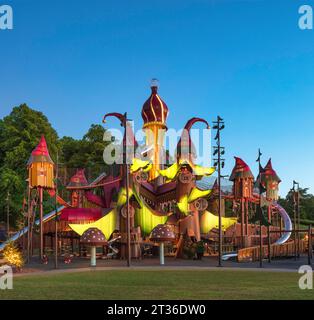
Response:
[142,79,169,180]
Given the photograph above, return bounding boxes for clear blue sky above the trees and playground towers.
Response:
[0,0,314,194]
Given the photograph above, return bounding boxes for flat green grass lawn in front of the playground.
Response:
[0,270,314,300]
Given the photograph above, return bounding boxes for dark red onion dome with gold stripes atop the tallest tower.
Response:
[142,79,169,128]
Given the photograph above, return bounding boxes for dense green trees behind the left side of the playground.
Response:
[0,104,107,227]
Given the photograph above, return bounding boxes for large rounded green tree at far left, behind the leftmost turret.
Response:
[0,104,58,226]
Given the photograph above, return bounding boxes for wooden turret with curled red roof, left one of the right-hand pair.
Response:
[229,157,254,199]
